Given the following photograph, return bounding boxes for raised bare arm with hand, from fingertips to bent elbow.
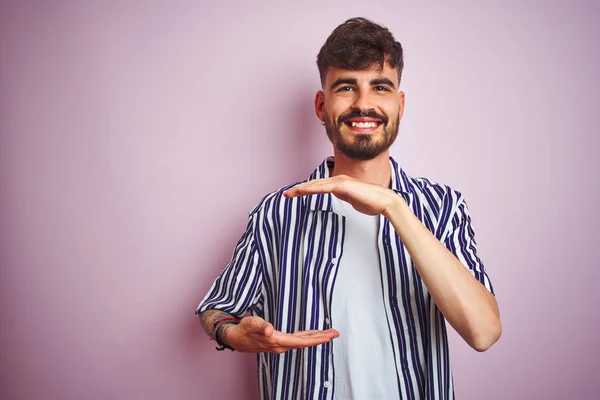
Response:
[284,175,502,351]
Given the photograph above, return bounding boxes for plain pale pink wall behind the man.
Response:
[0,0,600,400]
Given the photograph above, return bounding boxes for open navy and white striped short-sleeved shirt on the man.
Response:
[196,157,493,400]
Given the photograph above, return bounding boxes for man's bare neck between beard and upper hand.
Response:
[331,149,392,188]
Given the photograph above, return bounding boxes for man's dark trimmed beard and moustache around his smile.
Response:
[324,111,400,161]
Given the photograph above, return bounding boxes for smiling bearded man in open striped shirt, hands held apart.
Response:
[196,18,501,399]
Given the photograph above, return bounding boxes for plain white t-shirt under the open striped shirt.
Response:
[331,196,400,400]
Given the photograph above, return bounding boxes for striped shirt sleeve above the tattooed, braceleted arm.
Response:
[196,216,262,318]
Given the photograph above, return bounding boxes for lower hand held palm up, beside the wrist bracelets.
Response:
[223,317,340,354]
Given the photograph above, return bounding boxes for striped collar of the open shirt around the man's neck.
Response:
[303,156,412,212]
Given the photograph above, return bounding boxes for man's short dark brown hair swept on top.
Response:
[317,18,404,85]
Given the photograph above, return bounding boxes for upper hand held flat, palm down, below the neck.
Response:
[283,175,401,215]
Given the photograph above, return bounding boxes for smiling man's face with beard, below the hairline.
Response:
[315,63,404,161]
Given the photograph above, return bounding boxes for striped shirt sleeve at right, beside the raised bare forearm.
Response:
[443,197,494,294]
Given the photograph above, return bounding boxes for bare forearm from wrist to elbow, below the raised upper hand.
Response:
[384,196,501,351]
